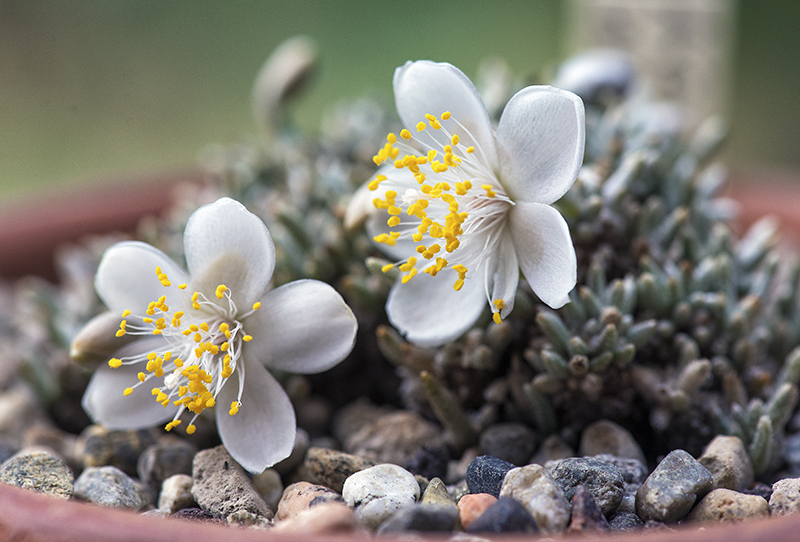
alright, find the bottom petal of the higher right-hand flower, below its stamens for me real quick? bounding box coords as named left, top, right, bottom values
left=386, top=266, right=486, bottom=347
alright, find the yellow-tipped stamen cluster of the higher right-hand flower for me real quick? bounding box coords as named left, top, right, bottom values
left=368, top=111, right=514, bottom=321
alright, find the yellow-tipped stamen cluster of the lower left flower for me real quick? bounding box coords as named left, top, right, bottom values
left=108, top=267, right=261, bottom=434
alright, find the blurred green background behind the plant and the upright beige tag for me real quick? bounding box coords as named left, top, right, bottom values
left=0, top=0, right=800, bottom=199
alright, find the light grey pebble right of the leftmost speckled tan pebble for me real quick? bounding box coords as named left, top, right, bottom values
left=75, top=465, right=150, bottom=510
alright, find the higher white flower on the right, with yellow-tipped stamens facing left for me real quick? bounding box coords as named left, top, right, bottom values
left=346, top=60, right=585, bottom=346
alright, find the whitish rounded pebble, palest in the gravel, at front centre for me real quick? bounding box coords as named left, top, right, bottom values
left=342, top=463, right=419, bottom=529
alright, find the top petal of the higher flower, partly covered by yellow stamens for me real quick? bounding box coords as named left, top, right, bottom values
left=394, top=60, right=497, bottom=170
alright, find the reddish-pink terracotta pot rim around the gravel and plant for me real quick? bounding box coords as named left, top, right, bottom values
left=0, top=172, right=800, bottom=542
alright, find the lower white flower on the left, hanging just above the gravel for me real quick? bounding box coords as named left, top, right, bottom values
left=83, top=198, right=357, bottom=472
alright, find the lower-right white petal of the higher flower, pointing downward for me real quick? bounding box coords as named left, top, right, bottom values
left=509, top=202, right=577, bottom=309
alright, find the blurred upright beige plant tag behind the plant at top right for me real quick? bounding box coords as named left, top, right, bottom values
left=567, top=0, right=734, bottom=123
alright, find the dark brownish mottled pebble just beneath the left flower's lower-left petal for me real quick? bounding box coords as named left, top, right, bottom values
left=76, top=425, right=156, bottom=476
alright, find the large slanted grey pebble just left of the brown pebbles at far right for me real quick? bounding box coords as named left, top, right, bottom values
left=636, top=450, right=713, bottom=523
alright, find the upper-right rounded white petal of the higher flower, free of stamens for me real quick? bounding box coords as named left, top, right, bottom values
left=497, top=86, right=586, bottom=203
